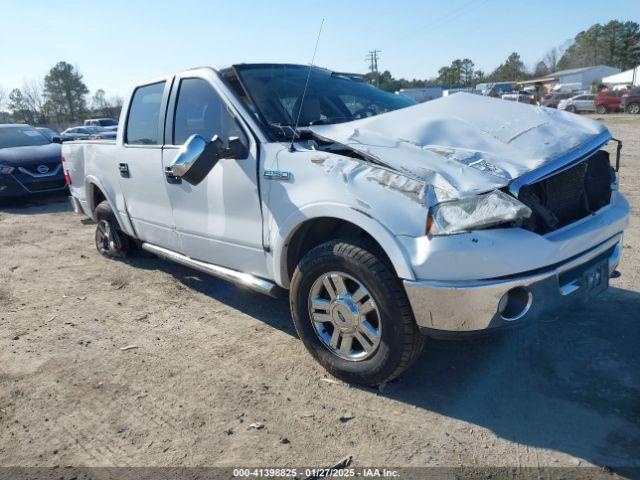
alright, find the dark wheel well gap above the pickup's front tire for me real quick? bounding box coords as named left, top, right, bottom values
left=284, top=217, right=395, bottom=284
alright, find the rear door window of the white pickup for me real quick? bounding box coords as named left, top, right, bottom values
left=125, top=82, right=164, bottom=145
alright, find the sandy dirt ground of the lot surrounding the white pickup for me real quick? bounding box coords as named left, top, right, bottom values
left=0, top=115, right=640, bottom=467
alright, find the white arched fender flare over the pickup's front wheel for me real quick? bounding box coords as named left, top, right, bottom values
left=270, top=204, right=415, bottom=288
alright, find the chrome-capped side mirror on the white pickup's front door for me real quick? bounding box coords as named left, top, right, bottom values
left=169, top=135, right=225, bottom=185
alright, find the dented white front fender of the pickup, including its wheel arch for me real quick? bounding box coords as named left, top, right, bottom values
left=263, top=145, right=428, bottom=287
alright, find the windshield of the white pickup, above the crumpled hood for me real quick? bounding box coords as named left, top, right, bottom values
left=234, top=64, right=416, bottom=135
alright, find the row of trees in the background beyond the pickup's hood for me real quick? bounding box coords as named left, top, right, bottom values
left=365, top=20, right=640, bottom=92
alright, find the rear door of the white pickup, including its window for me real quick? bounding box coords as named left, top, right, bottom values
left=114, top=79, right=179, bottom=250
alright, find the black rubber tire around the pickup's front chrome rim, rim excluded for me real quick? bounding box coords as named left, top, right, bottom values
left=290, top=240, right=425, bottom=385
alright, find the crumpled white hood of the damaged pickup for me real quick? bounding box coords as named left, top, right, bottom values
left=310, top=93, right=610, bottom=197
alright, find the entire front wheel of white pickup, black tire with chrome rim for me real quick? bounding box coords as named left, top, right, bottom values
left=290, top=240, right=425, bottom=385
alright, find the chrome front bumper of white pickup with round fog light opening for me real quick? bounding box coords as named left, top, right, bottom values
left=404, top=233, right=622, bottom=332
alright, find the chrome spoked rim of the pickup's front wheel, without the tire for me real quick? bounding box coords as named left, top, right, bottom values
left=309, top=272, right=382, bottom=361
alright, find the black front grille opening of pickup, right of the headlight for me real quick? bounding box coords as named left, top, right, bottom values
left=518, top=150, right=613, bottom=234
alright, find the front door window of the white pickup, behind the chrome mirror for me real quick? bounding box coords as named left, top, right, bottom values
left=173, top=78, right=248, bottom=152
